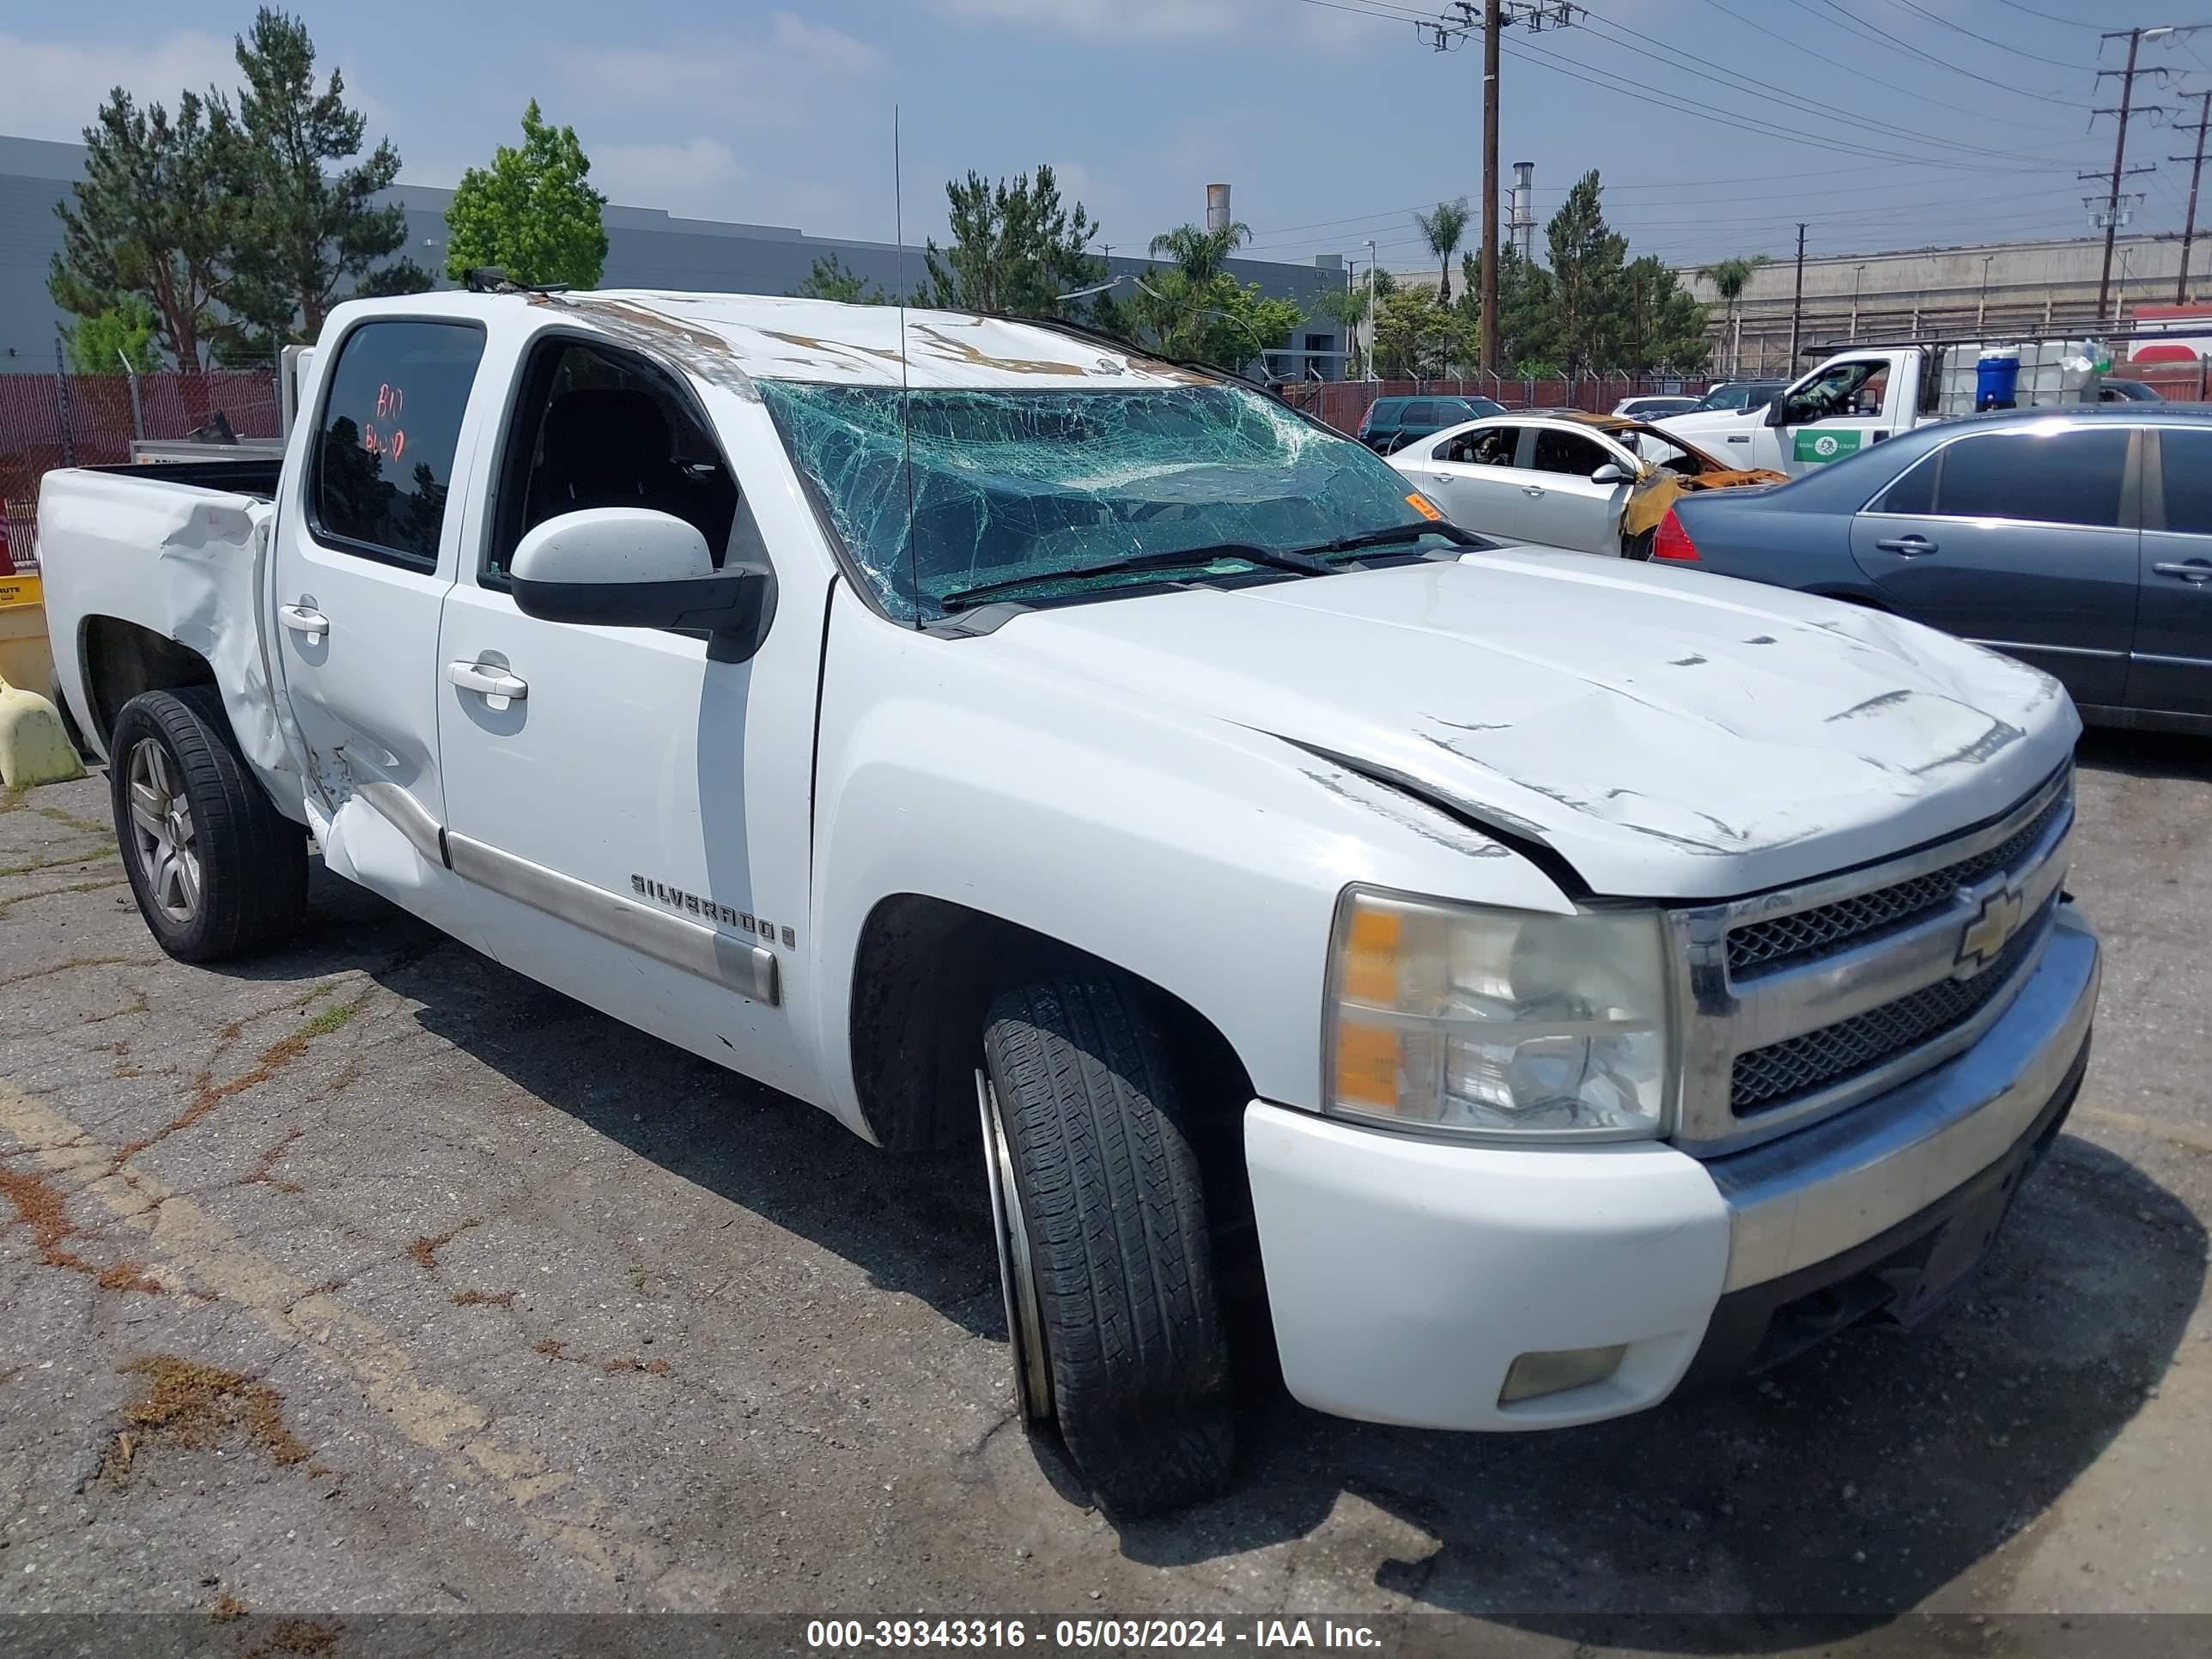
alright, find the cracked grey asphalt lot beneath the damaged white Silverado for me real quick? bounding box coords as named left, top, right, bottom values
left=0, top=734, right=2212, bottom=1652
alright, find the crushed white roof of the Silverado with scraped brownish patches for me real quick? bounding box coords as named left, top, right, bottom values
left=544, top=289, right=1207, bottom=392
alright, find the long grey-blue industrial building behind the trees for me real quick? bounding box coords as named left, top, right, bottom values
left=0, top=137, right=1345, bottom=380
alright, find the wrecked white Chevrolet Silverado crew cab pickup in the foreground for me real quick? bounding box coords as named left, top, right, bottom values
left=40, top=292, right=2100, bottom=1516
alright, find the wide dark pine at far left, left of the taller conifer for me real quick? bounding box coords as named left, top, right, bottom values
left=46, top=86, right=239, bottom=372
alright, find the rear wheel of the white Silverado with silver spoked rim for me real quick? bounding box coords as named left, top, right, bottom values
left=108, top=686, right=307, bottom=963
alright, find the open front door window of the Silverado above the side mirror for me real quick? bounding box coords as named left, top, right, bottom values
left=484, top=341, right=737, bottom=586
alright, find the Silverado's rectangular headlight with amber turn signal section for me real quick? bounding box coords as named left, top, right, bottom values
left=1325, top=887, right=1672, bottom=1139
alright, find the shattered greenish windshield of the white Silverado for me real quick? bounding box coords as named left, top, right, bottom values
left=759, top=380, right=1427, bottom=622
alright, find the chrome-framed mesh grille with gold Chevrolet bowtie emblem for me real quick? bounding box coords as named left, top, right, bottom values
left=1666, top=763, right=2073, bottom=1157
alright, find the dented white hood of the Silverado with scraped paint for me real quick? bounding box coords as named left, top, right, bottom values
left=991, top=549, right=2079, bottom=898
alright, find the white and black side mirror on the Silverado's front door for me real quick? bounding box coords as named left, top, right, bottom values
left=507, top=507, right=776, bottom=661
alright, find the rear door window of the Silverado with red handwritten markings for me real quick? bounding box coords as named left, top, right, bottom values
left=307, top=321, right=484, bottom=568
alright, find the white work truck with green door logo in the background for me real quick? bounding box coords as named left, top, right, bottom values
left=1652, top=338, right=2108, bottom=477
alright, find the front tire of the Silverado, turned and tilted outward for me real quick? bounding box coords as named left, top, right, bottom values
left=984, top=964, right=1234, bottom=1517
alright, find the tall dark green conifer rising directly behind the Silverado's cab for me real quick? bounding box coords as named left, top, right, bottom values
left=216, top=7, right=429, bottom=347
